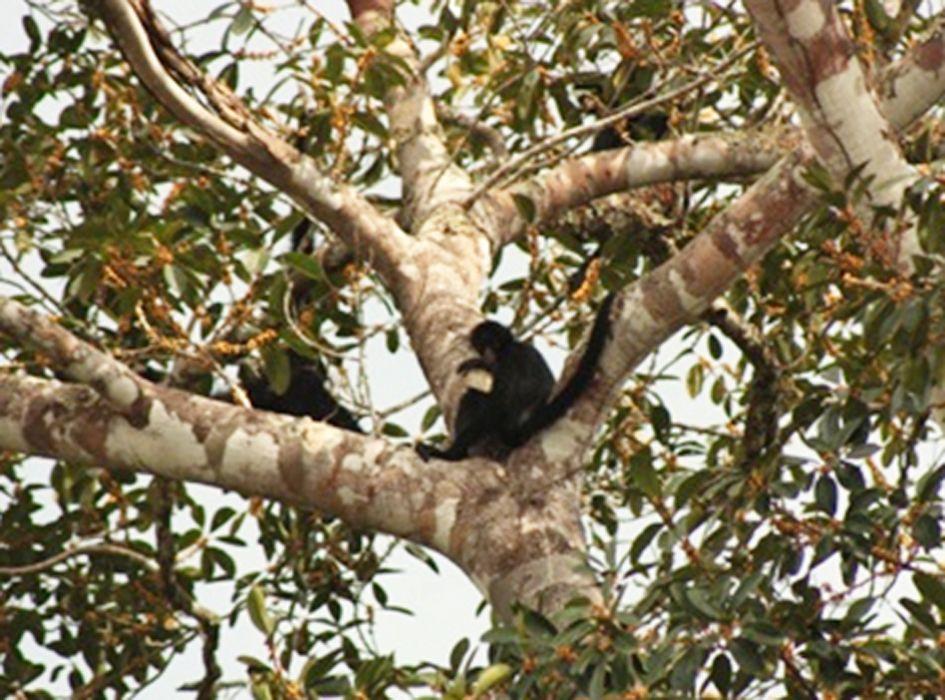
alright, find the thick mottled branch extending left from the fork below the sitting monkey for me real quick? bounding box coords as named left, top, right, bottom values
left=0, top=374, right=494, bottom=552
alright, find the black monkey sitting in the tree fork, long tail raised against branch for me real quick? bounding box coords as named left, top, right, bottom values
left=417, top=293, right=614, bottom=461
